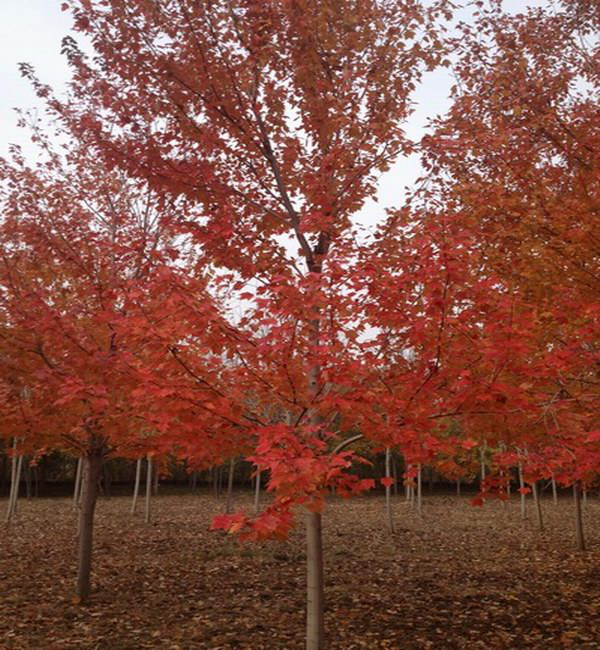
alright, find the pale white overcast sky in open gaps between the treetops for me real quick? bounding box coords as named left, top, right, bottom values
left=0, top=0, right=548, bottom=223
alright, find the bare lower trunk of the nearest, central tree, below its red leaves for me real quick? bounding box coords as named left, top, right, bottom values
left=306, top=512, right=325, bottom=650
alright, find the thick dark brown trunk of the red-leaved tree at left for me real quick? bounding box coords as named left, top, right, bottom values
left=77, top=451, right=102, bottom=605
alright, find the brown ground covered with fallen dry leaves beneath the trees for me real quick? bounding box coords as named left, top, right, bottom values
left=0, top=493, right=600, bottom=650
